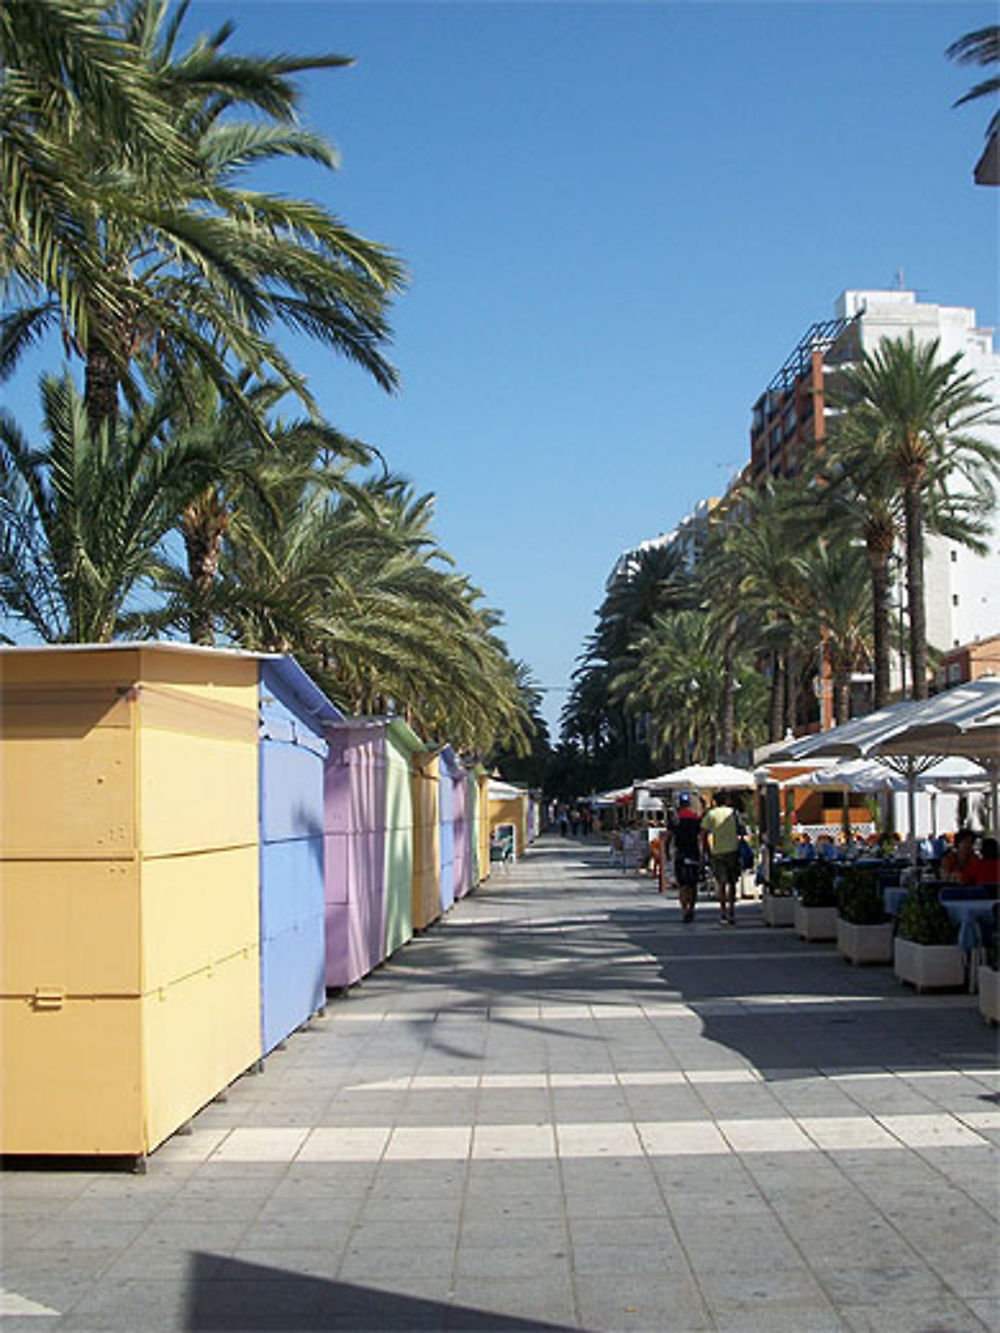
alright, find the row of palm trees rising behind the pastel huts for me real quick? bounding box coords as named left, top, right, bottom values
left=0, top=0, right=533, bottom=754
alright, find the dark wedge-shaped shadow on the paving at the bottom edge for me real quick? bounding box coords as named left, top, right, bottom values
left=184, top=1253, right=569, bottom=1333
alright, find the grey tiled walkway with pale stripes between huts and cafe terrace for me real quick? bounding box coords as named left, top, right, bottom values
left=0, top=838, right=1000, bottom=1333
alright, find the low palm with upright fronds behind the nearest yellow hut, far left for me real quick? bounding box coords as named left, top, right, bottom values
left=0, top=373, right=211, bottom=643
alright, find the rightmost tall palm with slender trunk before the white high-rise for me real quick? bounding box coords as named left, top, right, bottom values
left=831, top=333, right=1000, bottom=698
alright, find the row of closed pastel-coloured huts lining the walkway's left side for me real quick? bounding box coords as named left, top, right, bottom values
left=0, top=643, right=539, bottom=1161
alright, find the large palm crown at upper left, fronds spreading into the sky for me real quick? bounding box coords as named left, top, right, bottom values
left=0, top=0, right=403, bottom=424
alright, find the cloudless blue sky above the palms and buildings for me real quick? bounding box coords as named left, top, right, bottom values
left=3, top=0, right=1000, bottom=720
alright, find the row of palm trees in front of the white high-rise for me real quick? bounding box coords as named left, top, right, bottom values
left=563, top=336, right=1000, bottom=777
